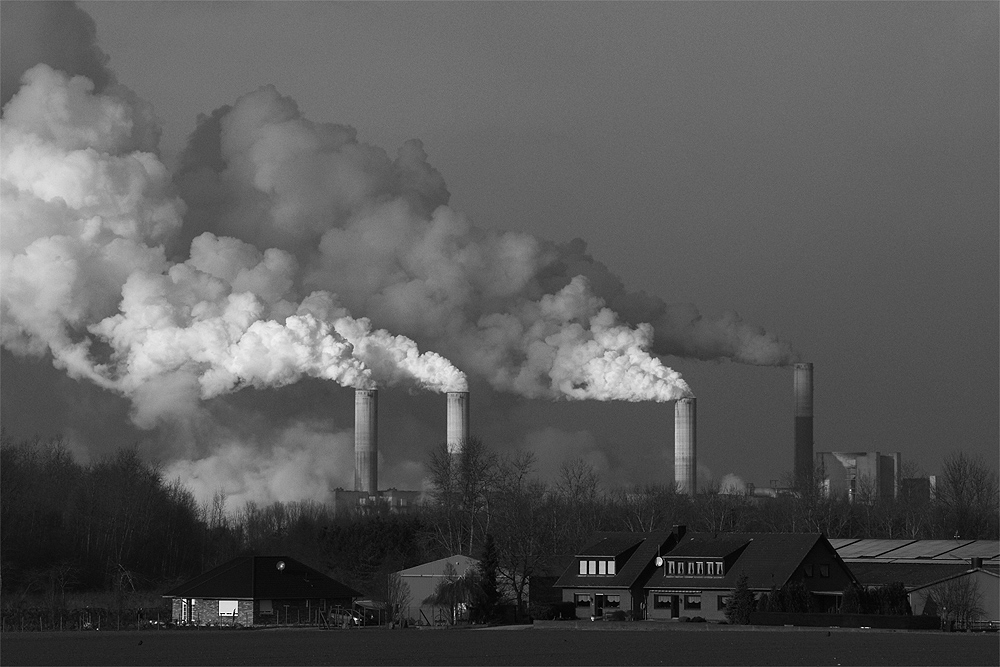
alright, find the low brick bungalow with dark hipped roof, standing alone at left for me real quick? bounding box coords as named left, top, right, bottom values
left=163, top=556, right=361, bottom=626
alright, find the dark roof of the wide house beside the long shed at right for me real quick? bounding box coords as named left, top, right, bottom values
left=644, top=533, right=836, bottom=590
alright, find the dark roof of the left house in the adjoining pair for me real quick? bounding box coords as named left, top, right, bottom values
left=554, top=530, right=674, bottom=588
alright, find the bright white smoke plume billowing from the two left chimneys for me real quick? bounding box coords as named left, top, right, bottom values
left=0, top=65, right=465, bottom=427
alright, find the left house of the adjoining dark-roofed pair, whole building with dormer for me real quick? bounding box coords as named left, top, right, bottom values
left=555, top=531, right=676, bottom=619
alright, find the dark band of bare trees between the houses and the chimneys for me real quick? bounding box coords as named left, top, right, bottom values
left=0, top=437, right=1000, bottom=608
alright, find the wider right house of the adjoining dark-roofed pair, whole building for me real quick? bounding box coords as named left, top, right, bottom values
left=643, top=527, right=857, bottom=620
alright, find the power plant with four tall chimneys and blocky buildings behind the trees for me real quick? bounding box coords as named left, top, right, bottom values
left=332, top=363, right=844, bottom=512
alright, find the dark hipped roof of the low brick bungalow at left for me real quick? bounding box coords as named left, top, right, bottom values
left=163, top=556, right=361, bottom=600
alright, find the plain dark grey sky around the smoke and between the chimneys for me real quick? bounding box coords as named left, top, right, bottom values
left=2, top=2, right=1000, bottom=508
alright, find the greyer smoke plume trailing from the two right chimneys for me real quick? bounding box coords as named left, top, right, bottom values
left=177, top=86, right=793, bottom=401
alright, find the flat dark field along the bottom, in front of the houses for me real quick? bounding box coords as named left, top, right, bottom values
left=0, top=628, right=1000, bottom=666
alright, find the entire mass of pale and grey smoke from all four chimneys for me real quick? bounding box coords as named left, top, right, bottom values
left=0, top=3, right=795, bottom=504
